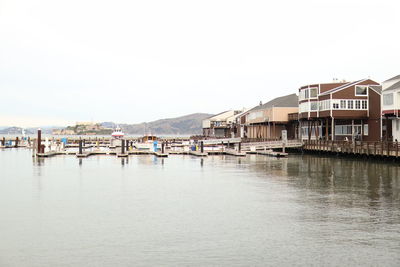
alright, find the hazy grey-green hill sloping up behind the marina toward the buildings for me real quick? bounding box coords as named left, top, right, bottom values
left=102, top=113, right=212, bottom=135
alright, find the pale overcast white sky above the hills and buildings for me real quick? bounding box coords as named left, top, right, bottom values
left=0, top=0, right=400, bottom=127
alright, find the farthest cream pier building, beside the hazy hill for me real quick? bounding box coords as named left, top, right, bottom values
left=202, top=110, right=243, bottom=138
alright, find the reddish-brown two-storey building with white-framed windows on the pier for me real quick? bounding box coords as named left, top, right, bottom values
left=299, top=79, right=382, bottom=141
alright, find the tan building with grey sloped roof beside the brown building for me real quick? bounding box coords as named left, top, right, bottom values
left=245, top=94, right=298, bottom=140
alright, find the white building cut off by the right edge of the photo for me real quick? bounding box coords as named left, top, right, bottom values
left=382, top=75, right=400, bottom=141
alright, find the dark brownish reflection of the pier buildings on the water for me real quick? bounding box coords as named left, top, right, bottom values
left=250, top=155, right=400, bottom=206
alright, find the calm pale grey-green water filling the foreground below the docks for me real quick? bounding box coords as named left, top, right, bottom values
left=0, top=149, right=400, bottom=267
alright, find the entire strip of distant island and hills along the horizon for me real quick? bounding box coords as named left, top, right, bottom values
left=0, top=113, right=213, bottom=135
